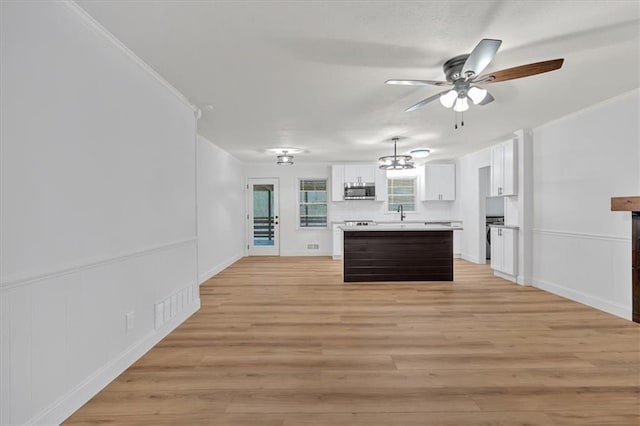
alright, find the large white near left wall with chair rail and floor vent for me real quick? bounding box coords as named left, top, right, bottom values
left=0, top=2, right=199, bottom=424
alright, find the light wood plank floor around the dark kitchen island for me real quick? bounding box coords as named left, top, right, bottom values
left=68, top=257, right=640, bottom=426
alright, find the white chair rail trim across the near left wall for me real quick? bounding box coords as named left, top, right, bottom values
left=0, top=237, right=198, bottom=291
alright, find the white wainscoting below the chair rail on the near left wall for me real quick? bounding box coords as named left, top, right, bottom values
left=0, top=239, right=199, bottom=424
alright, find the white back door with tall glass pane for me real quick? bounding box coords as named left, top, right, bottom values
left=247, top=178, right=280, bottom=256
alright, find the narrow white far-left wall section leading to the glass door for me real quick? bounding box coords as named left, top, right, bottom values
left=197, top=136, right=246, bottom=283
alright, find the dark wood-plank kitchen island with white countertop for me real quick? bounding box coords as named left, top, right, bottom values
left=342, top=224, right=462, bottom=282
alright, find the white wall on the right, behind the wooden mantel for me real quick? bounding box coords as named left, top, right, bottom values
left=533, top=90, right=640, bottom=318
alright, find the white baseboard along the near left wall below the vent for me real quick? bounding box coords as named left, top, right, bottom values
left=26, top=298, right=200, bottom=425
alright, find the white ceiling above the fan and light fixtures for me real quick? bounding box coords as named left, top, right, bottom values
left=78, top=0, right=640, bottom=164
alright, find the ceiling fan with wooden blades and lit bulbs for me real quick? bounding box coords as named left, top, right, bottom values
left=386, top=38, right=564, bottom=118
